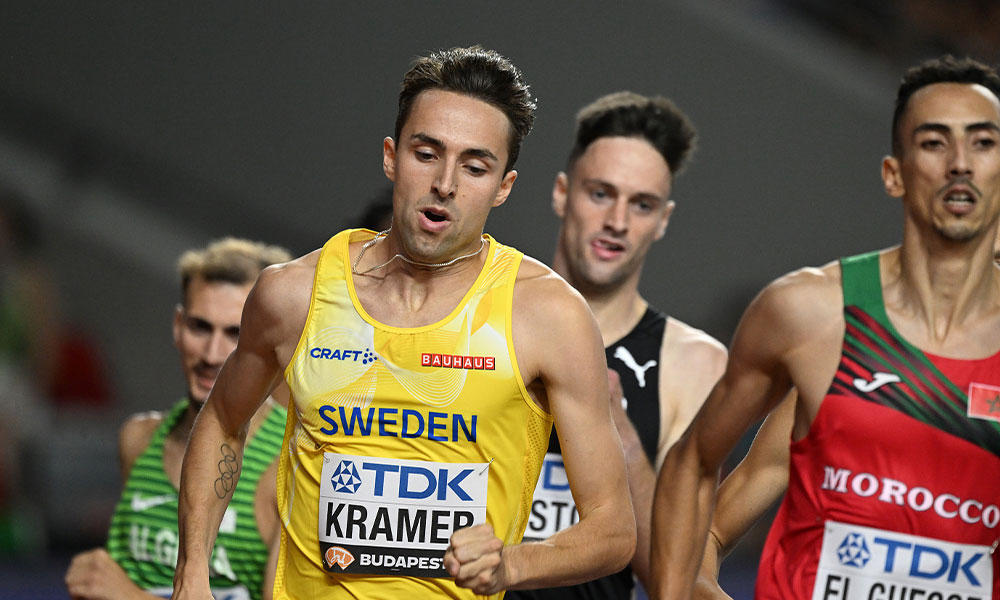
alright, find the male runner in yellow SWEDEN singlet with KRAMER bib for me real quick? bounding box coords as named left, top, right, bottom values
left=175, top=47, right=635, bottom=600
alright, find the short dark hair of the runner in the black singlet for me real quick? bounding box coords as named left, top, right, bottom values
left=568, top=92, right=697, bottom=174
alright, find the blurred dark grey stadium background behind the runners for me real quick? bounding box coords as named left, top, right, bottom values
left=0, top=0, right=1000, bottom=598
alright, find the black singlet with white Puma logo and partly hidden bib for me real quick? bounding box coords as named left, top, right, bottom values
left=507, top=307, right=667, bottom=600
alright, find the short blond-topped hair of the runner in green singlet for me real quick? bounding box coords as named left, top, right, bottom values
left=177, top=237, right=292, bottom=305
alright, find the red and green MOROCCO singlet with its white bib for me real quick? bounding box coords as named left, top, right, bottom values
left=756, top=253, right=1000, bottom=600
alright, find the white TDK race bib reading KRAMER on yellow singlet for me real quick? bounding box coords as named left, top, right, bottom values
left=319, top=452, right=489, bottom=577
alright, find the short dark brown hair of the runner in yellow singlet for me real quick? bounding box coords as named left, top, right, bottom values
left=396, top=46, right=536, bottom=172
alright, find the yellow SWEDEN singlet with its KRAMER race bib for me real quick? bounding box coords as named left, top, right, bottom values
left=275, top=230, right=552, bottom=599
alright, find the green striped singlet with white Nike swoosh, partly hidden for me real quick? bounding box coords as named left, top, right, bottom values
left=108, top=399, right=286, bottom=600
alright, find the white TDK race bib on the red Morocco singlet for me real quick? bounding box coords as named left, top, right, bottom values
left=812, top=521, right=993, bottom=600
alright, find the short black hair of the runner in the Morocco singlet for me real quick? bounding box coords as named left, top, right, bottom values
left=892, top=54, right=1000, bottom=155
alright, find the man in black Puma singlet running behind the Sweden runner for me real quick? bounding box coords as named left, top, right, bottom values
left=507, top=92, right=725, bottom=599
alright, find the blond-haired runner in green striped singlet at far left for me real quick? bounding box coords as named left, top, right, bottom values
left=66, top=238, right=290, bottom=600
